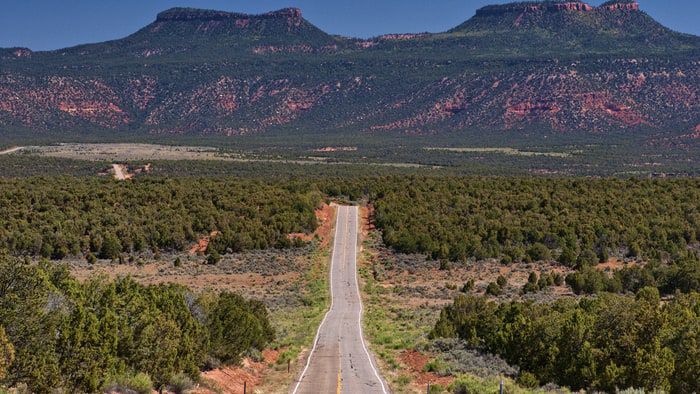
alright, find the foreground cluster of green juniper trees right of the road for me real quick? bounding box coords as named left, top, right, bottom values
left=431, top=287, right=700, bottom=394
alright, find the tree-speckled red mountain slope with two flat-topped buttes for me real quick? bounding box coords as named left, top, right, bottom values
left=0, top=1, right=700, bottom=135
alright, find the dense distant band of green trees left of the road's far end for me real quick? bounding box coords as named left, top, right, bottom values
left=0, top=177, right=321, bottom=259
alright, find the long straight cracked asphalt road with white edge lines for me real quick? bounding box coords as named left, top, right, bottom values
left=291, top=206, right=388, bottom=394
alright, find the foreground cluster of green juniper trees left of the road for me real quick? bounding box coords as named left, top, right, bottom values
left=0, top=256, right=274, bottom=392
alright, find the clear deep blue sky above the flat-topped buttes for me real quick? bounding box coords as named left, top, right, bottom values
left=0, top=0, right=700, bottom=50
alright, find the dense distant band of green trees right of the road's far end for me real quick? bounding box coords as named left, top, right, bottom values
left=360, top=177, right=700, bottom=267
